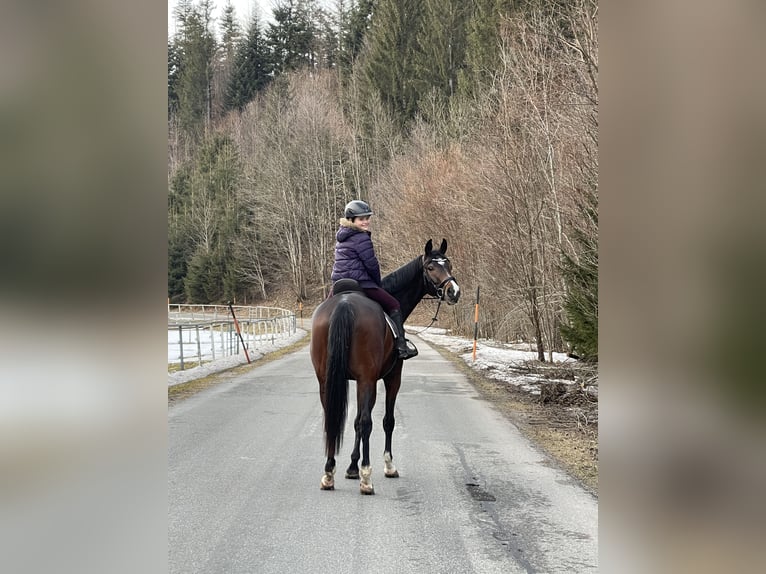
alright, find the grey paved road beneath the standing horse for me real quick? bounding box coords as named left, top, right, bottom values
left=168, top=341, right=598, bottom=574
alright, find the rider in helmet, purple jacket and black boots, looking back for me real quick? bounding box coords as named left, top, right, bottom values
left=332, top=199, right=418, bottom=360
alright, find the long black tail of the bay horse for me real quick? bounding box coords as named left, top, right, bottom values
left=324, top=300, right=354, bottom=456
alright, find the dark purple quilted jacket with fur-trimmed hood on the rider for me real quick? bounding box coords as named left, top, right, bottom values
left=332, top=218, right=382, bottom=288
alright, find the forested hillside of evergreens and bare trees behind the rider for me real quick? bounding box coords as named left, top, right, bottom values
left=167, top=0, right=599, bottom=361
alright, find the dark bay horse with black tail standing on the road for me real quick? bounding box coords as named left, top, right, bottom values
left=310, top=239, right=460, bottom=494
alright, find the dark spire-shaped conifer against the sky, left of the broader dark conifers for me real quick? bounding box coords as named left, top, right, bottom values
left=225, top=13, right=271, bottom=110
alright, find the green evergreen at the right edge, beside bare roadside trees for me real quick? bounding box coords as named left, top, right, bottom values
left=561, top=193, right=598, bottom=362
